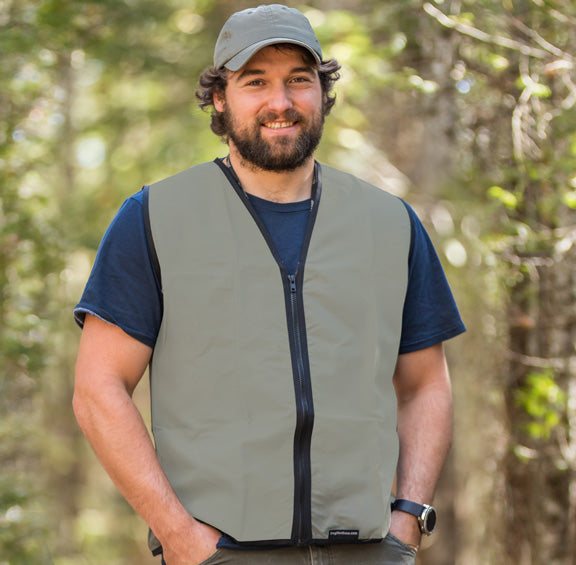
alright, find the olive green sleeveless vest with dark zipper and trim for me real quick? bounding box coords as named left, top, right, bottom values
left=148, top=162, right=411, bottom=545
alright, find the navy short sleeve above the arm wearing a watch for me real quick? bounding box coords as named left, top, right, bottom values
left=399, top=203, right=466, bottom=353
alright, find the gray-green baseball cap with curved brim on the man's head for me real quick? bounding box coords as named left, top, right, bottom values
left=214, top=4, right=322, bottom=71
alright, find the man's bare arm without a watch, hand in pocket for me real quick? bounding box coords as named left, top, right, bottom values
left=73, top=315, right=220, bottom=565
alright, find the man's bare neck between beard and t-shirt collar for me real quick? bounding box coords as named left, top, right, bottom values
left=230, top=144, right=314, bottom=203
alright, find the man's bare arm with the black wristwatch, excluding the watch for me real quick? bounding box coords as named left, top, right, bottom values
left=390, top=343, right=452, bottom=546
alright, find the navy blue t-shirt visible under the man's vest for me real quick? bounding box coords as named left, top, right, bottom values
left=74, top=185, right=465, bottom=353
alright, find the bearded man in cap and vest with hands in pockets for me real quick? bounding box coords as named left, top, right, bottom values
left=74, top=5, right=464, bottom=565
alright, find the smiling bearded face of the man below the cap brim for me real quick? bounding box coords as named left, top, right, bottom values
left=214, top=46, right=324, bottom=172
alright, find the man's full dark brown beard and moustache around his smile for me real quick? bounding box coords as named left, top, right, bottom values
left=223, top=106, right=324, bottom=172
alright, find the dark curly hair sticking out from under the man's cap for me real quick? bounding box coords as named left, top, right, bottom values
left=196, top=44, right=340, bottom=141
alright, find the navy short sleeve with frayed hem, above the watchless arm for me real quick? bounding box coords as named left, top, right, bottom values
left=74, top=193, right=162, bottom=347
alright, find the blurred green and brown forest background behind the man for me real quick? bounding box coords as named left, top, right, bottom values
left=0, top=0, right=576, bottom=565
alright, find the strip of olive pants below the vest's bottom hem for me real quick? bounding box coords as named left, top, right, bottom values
left=160, top=534, right=416, bottom=565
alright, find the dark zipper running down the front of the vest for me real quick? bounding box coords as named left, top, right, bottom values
left=288, top=275, right=314, bottom=545
